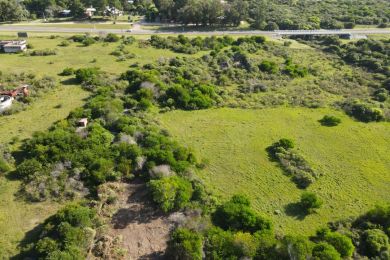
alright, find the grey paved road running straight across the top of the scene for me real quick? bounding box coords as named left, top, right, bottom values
left=0, top=25, right=390, bottom=36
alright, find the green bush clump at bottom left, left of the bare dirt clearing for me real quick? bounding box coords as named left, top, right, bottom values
left=21, top=204, right=96, bottom=259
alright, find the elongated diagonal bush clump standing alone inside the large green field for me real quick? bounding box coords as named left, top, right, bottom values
left=267, top=139, right=319, bottom=189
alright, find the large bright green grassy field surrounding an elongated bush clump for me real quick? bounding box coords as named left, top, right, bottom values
left=158, top=107, right=390, bottom=234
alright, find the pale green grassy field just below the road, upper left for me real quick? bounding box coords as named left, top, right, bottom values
left=0, top=35, right=202, bottom=76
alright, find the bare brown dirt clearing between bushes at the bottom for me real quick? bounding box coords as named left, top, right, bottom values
left=110, top=183, right=172, bottom=260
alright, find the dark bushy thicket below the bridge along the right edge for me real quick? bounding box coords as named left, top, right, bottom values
left=299, top=36, right=390, bottom=122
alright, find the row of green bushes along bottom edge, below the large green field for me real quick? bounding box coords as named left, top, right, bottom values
left=167, top=195, right=362, bottom=260
